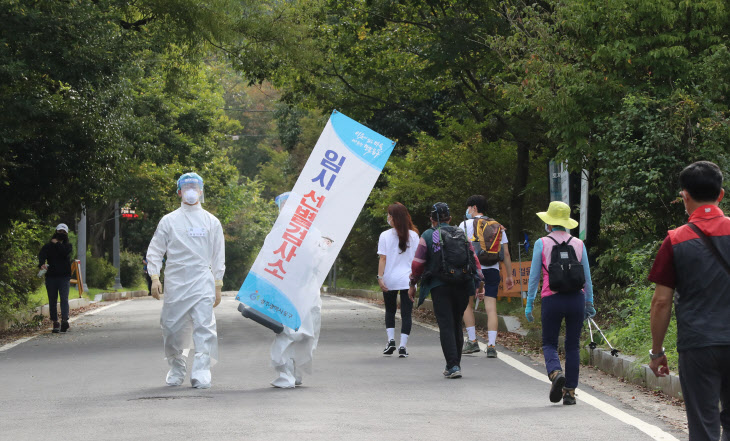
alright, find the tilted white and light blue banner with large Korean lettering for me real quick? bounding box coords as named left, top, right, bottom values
left=236, top=110, right=395, bottom=330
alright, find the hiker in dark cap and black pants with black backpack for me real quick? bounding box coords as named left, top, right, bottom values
left=408, top=202, right=484, bottom=378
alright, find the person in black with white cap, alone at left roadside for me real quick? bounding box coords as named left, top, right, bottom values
left=38, top=224, right=73, bottom=334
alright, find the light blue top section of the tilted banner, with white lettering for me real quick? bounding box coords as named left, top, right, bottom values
left=328, top=110, right=395, bottom=172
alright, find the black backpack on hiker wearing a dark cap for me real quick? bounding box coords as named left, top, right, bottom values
left=432, top=226, right=476, bottom=283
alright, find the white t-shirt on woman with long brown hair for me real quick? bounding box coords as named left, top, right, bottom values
left=378, top=228, right=419, bottom=291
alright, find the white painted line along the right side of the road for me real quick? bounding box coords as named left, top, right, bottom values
left=336, top=297, right=679, bottom=441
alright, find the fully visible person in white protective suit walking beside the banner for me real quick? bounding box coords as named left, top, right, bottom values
left=147, top=173, right=226, bottom=389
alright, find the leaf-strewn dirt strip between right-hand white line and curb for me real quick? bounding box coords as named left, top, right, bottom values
left=349, top=297, right=687, bottom=433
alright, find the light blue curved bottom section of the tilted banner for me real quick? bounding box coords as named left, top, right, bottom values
left=236, top=271, right=302, bottom=331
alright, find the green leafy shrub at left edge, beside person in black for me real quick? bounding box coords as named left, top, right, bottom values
left=0, top=222, right=47, bottom=318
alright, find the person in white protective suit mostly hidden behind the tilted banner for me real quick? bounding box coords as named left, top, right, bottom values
left=271, top=193, right=322, bottom=388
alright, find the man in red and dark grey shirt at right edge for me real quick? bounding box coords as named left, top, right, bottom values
left=649, top=161, right=730, bottom=441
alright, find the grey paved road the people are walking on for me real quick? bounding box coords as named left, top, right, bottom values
left=0, top=296, right=686, bottom=441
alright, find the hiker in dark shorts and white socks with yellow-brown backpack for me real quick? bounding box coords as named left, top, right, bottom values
left=459, top=194, right=514, bottom=358
